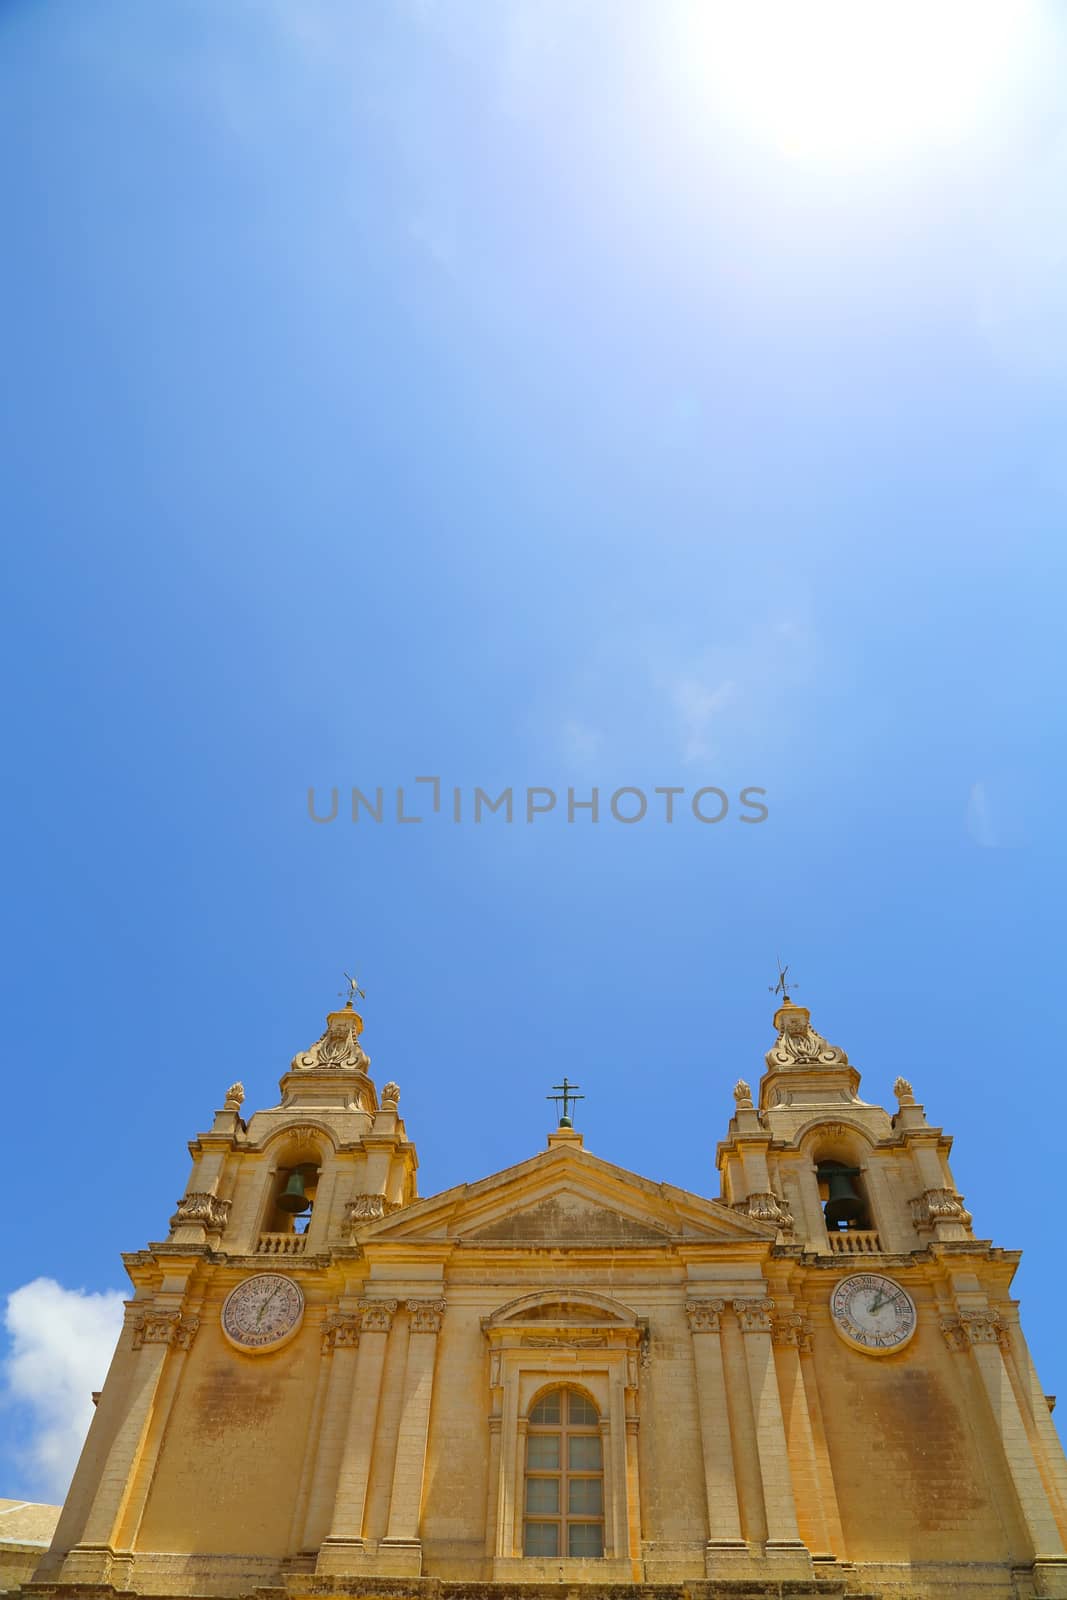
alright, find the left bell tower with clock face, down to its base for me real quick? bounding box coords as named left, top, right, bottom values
left=37, top=986, right=418, bottom=1592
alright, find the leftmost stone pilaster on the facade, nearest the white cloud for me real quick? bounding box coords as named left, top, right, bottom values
left=56, top=1307, right=200, bottom=1584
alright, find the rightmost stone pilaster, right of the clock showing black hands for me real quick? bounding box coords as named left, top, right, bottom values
left=941, top=1307, right=1067, bottom=1574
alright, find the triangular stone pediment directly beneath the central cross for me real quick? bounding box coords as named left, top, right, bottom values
left=358, top=1147, right=776, bottom=1250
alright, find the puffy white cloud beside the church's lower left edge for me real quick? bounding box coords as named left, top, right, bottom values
left=0, top=1278, right=123, bottom=1502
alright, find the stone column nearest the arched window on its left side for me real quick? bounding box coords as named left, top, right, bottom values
left=379, top=1299, right=445, bottom=1576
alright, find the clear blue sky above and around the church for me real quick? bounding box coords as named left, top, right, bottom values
left=0, top=0, right=1067, bottom=1498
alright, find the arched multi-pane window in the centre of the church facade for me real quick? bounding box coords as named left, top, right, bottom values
left=523, top=1389, right=603, bottom=1557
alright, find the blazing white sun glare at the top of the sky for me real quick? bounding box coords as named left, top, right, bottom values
left=675, top=0, right=1037, bottom=163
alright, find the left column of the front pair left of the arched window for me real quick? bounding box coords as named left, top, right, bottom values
left=319, top=1301, right=397, bottom=1573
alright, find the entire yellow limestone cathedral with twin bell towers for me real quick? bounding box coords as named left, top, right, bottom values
left=12, top=986, right=1067, bottom=1600
